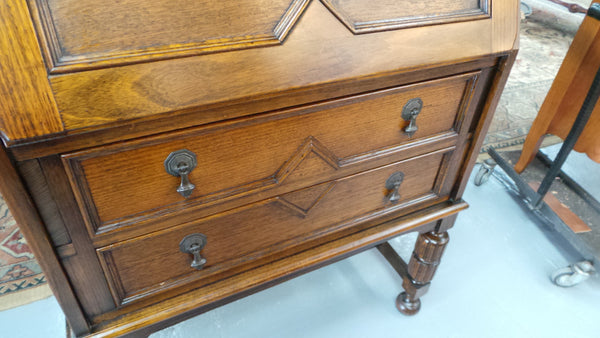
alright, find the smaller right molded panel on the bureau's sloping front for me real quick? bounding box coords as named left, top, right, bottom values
left=321, top=0, right=491, bottom=34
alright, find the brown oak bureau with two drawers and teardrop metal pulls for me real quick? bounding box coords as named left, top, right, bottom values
left=0, top=0, right=519, bottom=337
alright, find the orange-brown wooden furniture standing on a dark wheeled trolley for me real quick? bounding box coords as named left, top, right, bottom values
left=475, top=1, right=600, bottom=287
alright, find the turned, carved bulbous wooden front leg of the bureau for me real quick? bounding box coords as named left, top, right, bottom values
left=396, top=231, right=448, bottom=315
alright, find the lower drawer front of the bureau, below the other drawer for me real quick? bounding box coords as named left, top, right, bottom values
left=97, top=149, right=452, bottom=304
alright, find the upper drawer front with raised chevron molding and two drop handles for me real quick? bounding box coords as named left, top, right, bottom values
left=63, top=73, right=479, bottom=234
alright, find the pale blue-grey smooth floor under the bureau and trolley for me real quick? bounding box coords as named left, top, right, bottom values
left=0, top=149, right=600, bottom=338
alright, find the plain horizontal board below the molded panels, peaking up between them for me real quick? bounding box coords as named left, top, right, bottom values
left=52, top=0, right=518, bottom=130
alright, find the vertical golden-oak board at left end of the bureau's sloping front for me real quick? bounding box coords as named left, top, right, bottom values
left=0, top=0, right=63, bottom=142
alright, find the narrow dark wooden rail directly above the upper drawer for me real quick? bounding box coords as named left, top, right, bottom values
left=10, top=55, right=498, bottom=161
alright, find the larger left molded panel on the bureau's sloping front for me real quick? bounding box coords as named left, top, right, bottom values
left=28, top=0, right=310, bottom=74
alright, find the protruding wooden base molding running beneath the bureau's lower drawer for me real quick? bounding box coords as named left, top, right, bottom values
left=92, top=202, right=468, bottom=337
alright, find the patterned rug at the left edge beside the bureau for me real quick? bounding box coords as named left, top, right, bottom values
left=0, top=196, right=50, bottom=310
